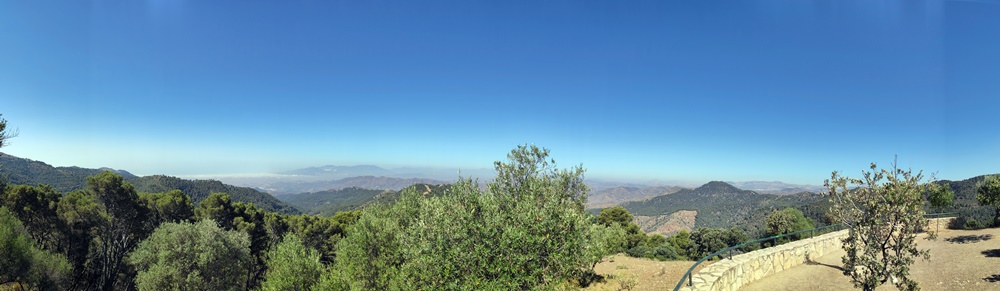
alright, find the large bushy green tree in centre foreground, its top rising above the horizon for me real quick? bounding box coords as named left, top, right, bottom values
left=335, top=146, right=611, bottom=289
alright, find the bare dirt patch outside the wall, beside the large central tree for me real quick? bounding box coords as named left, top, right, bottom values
left=584, top=254, right=710, bottom=290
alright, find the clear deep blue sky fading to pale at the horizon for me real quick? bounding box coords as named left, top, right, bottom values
left=0, top=0, right=1000, bottom=184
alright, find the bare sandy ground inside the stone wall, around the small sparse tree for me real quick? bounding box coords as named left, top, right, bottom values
left=741, top=228, right=1000, bottom=290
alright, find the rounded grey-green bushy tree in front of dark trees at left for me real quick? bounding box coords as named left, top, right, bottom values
left=128, top=219, right=252, bottom=290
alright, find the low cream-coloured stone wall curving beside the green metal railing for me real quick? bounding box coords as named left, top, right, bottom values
left=681, top=230, right=847, bottom=290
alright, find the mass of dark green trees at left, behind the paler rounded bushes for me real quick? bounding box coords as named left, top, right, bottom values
left=0, top=171, right=359, bottom=290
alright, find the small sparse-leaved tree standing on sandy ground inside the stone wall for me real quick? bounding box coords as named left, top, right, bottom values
left=825, top=163, right=930, bottom=290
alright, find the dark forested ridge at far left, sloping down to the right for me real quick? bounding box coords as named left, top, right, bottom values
left=0, top=154, right=299, bottom=214
